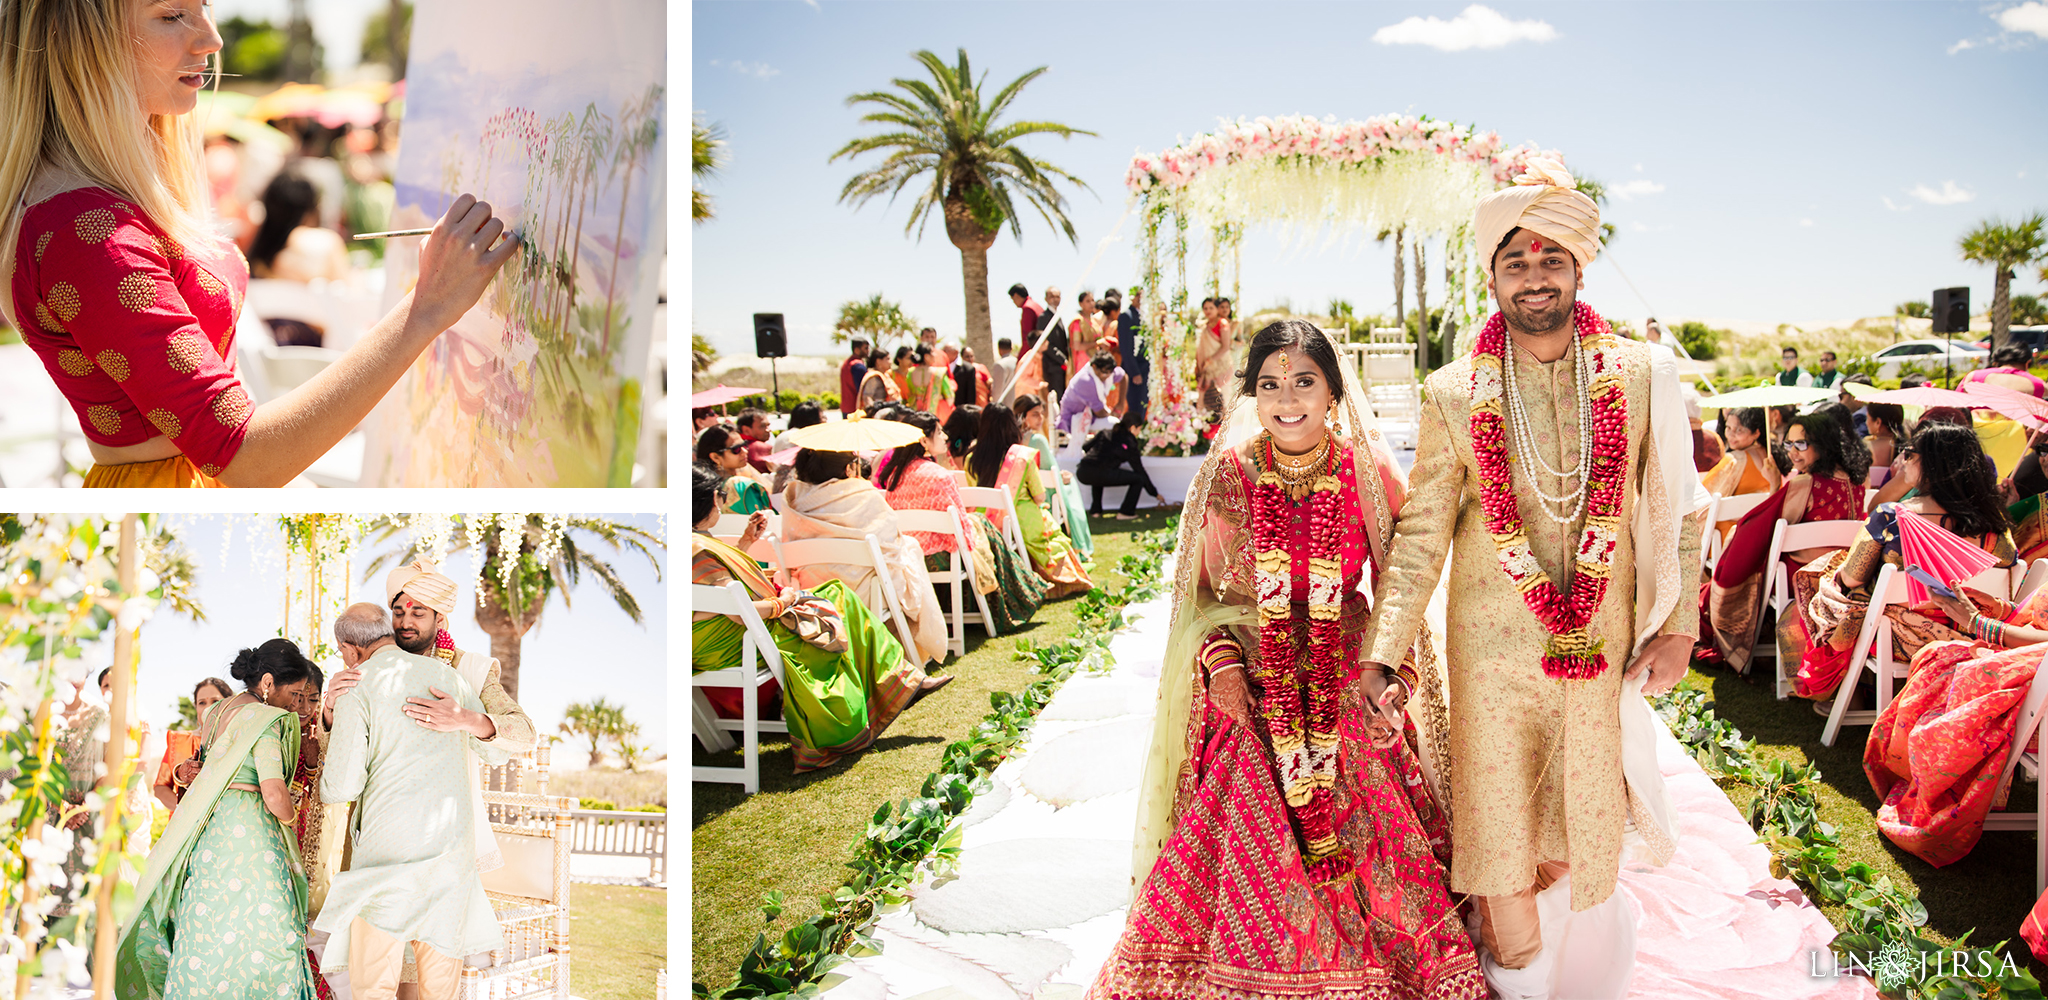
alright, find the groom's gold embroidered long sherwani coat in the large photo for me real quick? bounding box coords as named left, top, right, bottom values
left=1364, top=338, right=1700, bottom=910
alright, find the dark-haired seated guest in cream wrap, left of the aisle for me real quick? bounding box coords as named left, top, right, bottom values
left=782, top=449, right=946, bottom=664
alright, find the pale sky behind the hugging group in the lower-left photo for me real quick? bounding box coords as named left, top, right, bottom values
left=96, top=514, right=668, bottom=760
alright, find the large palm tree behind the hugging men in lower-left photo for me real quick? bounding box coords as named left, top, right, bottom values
left=362, top=514, right=668, bottom=701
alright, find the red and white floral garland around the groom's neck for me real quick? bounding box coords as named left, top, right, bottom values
left=1470, top=301, right=1628, bottom=680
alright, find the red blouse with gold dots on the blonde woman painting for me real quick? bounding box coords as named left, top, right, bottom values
left=12, top=189, right=256, bottom=475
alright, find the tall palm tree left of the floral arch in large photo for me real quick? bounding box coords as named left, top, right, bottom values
left=831, top=49, right=1094, bottom=359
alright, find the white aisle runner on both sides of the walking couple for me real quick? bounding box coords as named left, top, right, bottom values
left=825, top=568, right=1876, bottom=1000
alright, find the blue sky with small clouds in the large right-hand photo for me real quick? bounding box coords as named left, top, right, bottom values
left=688, top=0, right=2048, bottom=355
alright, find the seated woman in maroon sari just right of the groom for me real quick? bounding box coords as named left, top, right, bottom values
left=1694, top=414, right=1870, bottom=674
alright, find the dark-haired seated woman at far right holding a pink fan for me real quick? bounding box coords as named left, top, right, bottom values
left=1780, top=420, right=2013, bottom=701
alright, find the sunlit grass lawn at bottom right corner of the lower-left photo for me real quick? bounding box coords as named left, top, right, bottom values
left=569, top=885, right=668, bottom=1000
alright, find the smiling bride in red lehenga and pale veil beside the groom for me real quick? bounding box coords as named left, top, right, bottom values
left=1090, top=320, right=1487, bottom=1000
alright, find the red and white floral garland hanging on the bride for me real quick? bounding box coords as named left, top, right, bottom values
left=1251, top=436, right=1350, bottom=881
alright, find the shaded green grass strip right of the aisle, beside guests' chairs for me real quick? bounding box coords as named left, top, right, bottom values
left=1681, top=660, right=2048, bottom=977
